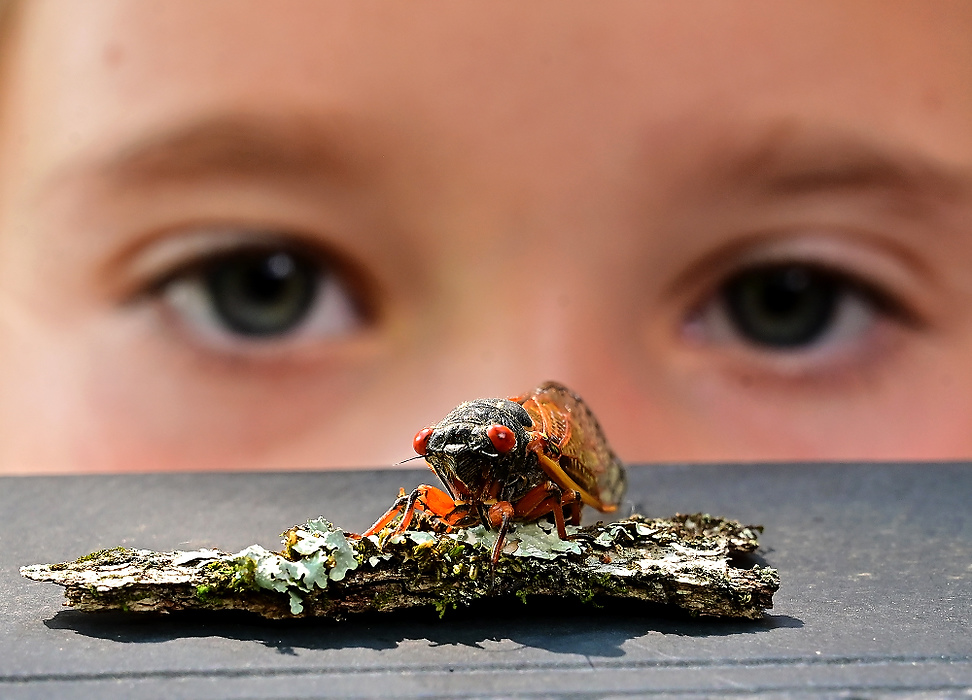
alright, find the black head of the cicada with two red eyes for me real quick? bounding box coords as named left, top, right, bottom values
left=415, top=399, right=533, bottom=501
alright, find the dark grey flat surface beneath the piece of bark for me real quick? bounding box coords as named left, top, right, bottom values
left=0, top=464, right=972, bottom=698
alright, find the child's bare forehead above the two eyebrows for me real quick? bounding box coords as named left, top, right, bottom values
left=9, top=0, right=972, bottom=179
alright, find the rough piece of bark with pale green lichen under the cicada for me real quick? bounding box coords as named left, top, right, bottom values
left=21, top=514, right=779, bottom=619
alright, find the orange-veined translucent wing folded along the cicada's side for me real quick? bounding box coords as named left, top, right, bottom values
left=513, top=382, right=627, bottom=511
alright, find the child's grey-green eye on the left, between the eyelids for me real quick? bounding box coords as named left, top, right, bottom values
left=161, top=245, right=363, bottom=343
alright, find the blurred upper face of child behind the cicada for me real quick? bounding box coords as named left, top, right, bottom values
left=0, top=0, right=972, bottom=471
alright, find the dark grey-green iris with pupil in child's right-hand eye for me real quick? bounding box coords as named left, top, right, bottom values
left=724, top=265, right=842, bottom=348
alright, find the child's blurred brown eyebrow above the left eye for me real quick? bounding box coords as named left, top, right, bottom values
left=79, top=115, right=366, bottom=191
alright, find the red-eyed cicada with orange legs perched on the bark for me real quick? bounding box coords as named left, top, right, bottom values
left=363, top=382, right=626, bottom=567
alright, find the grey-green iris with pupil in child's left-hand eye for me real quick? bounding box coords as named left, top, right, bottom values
left=204, top=251, right=320, bottom=337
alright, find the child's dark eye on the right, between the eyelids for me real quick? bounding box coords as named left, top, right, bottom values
left=691, top=262, right=905, bottom=353
